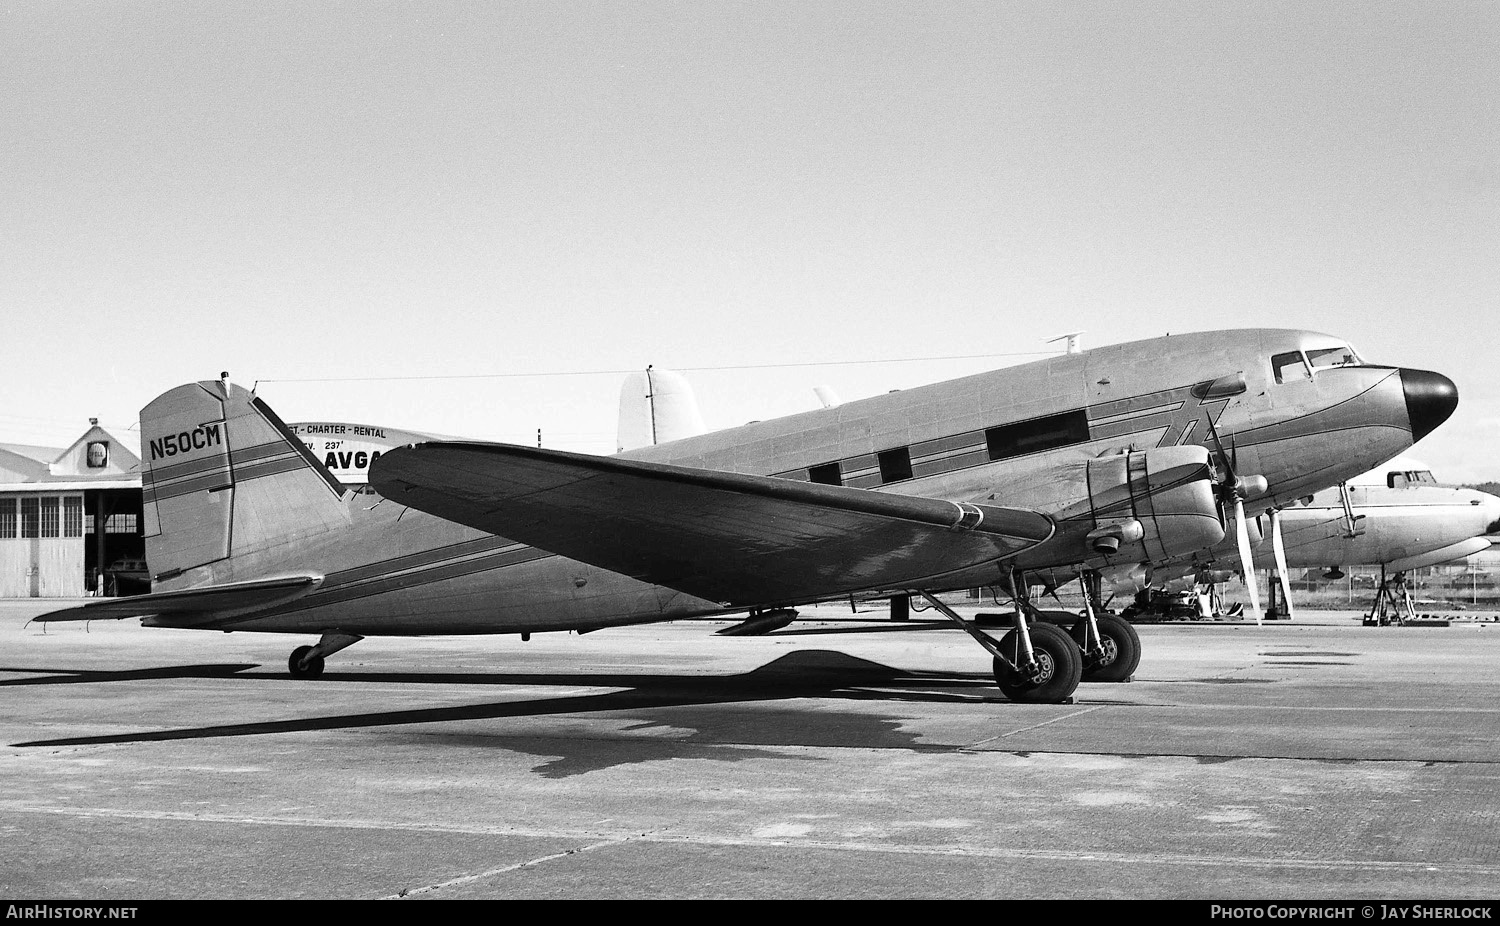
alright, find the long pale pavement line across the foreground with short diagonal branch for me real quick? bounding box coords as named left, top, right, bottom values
left=0, top=801, right=1500, bottom=876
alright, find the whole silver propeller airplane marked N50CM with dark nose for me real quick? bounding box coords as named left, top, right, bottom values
left=38, top=329, right=1458, bottom=704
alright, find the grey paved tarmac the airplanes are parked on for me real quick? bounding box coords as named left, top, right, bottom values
left=0, top=600, right=1500, bottom=900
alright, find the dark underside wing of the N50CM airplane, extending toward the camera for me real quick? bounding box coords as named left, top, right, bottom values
left=371, top=441, right=1055, bottom=606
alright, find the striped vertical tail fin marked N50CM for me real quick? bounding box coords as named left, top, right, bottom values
left=141, top=380, right=348, bottom=579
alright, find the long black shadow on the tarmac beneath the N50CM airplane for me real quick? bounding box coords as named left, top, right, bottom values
left=14, top=650, right=1008, bottom=746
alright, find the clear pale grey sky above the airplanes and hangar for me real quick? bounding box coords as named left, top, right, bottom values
left=0, top=0, right=1500, bottom=483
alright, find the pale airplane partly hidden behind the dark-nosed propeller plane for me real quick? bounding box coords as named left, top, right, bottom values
left=1134, top=456, right=1500, bottom=624
